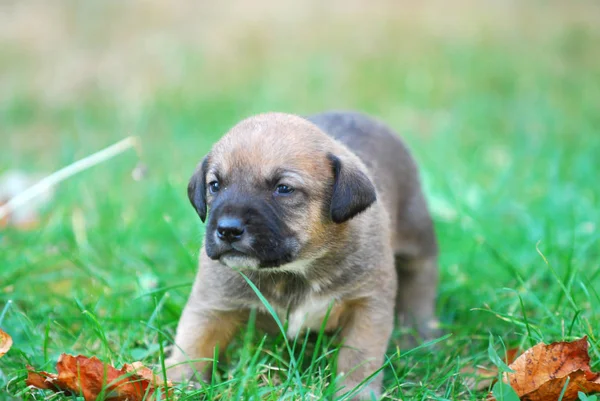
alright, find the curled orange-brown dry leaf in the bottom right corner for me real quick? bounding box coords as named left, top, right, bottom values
left=488, top=337, right=600, bottom=401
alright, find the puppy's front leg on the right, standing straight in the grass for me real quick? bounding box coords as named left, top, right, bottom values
left=338, top=299, right=394, bottom=400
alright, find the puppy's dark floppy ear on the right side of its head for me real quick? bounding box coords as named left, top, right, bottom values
left=327, top=153, right=377, bottom=223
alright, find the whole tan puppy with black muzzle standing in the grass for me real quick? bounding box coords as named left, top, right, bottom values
left=167, top=113, right=437, bottom=399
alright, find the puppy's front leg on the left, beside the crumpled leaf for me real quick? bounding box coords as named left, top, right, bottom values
left=165, top=304, right=243, bottom=382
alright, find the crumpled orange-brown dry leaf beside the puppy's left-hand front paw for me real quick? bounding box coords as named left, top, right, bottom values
left=27, top=354, right=171, bottom=401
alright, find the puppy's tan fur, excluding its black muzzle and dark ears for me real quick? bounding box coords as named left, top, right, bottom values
left=167, top=113, right=437, bottom=399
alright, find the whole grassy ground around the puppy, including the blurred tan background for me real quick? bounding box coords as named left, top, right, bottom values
left=0, top=1, right=600, bottom=400
